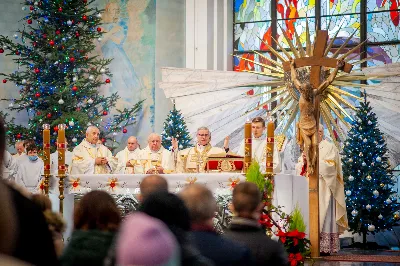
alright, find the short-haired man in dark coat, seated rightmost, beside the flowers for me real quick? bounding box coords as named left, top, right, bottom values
left=225, top=182, right=288, bottom=266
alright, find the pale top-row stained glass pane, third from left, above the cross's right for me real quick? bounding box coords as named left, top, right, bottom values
left=317, top=0, right=361, bottom=16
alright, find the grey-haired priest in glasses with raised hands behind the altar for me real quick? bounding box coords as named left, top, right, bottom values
left=177, top=127, right=229, bottom=173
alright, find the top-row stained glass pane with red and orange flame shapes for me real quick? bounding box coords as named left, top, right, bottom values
left=276, top=0, right=315, bottom=19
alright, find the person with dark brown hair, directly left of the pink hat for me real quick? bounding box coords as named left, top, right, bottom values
left=60, top=190, right=121, bottom=266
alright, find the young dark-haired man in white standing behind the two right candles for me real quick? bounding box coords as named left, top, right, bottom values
left=238, top=116, right=282, bottom=173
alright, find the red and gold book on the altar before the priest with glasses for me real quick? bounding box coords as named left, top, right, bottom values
left=205, top=152, right=244, bottom=172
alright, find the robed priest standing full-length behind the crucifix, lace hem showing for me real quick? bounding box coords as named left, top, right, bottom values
left=296, top=125, right=348, bottom=254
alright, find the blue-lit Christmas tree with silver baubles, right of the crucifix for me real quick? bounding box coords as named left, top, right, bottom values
left=342, top=95, right=399, bottom=244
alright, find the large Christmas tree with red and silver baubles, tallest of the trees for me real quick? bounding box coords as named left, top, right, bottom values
left=0, top=0, right=142, bottom=150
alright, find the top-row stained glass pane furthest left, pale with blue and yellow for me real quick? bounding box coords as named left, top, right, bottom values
left=234, top=0, right=271, bottom=23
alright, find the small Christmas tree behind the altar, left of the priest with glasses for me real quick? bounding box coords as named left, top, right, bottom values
left=161, top=104, right=192, bottom=150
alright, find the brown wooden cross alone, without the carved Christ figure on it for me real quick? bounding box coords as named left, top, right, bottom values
left=283, top=30, right=353, bottom=258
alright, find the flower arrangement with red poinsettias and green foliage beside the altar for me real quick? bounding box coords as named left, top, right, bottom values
left=246, top=161, right=311, bottom=266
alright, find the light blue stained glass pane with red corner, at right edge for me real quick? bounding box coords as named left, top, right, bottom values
left=367, top=11, right=400, bottom=42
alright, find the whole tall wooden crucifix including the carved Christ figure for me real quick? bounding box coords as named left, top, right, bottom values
left=283, top=30, right=353, bottom=258
